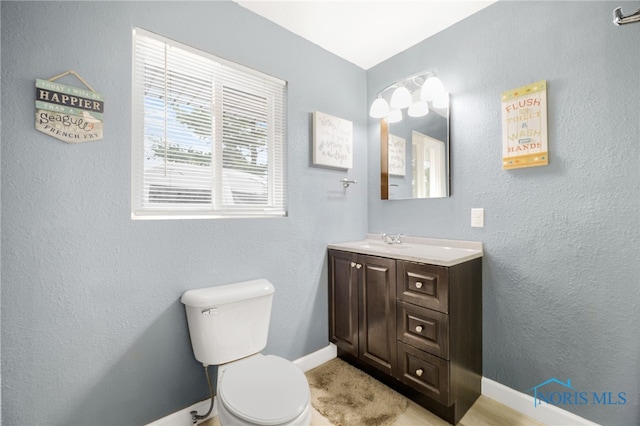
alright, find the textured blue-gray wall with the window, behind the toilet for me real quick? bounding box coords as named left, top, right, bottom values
left=1, top=1, right=367, bottom=425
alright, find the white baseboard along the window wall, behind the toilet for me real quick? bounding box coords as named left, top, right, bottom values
left=146, top=343, right=337, bottom=426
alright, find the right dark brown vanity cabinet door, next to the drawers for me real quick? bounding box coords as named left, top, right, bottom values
left=357, top=256, right=397, bottom=375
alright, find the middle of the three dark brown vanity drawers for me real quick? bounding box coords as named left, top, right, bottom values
left=396, top=302, right=449, bottom=359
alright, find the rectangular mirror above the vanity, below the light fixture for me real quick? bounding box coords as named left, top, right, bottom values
left=380, top=94, right=450, bottom=200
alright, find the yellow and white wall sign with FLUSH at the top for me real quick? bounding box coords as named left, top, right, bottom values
left=502, top=80, right=549, bottom=170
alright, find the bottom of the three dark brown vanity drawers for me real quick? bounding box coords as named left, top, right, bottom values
left=398, top=342, right=450, bottom=406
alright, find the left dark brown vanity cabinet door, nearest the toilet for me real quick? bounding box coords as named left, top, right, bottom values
left=329, top=250, right=358, bottom=356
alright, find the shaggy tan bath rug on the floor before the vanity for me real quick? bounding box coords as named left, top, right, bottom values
left=306, top=358, right=409, bottom=426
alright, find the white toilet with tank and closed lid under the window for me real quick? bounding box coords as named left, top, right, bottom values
left=181, top=279, right=311, bottom=426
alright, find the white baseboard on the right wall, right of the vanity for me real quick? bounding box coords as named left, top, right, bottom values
left=482, top=377, right=598, bottom=426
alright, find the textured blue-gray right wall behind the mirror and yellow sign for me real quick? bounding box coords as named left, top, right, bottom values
left=367, top=1, right=640, bottom=425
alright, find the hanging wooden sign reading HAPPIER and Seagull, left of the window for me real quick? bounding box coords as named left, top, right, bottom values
left=36, top=71, right=104, bottom=143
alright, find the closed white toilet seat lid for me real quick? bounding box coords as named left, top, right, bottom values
left=218, top=355, right=310, bottom=426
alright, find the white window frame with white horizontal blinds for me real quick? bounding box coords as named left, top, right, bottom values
left=131, top=27, right=287, bottom=219
